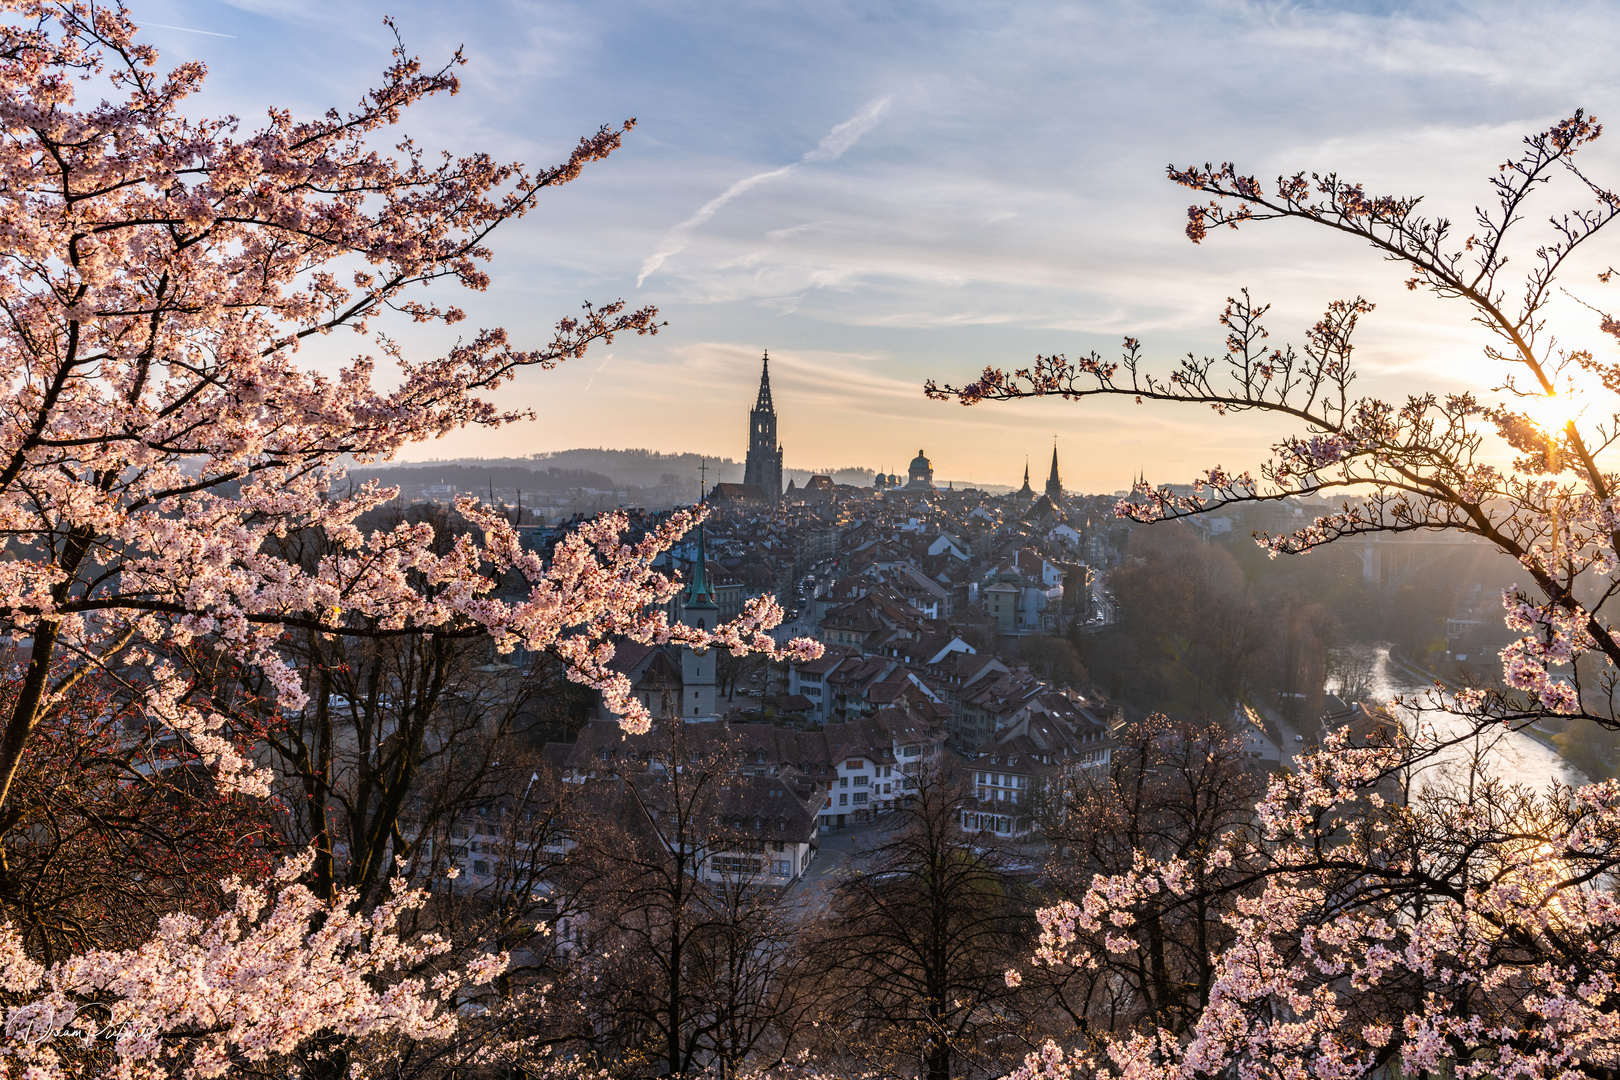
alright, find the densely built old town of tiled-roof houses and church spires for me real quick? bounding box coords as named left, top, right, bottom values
left=440, top=354, right=1278, bottom=887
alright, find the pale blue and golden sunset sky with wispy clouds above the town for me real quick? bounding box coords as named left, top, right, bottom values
left=131, top=0, right=1620, bottom=491
